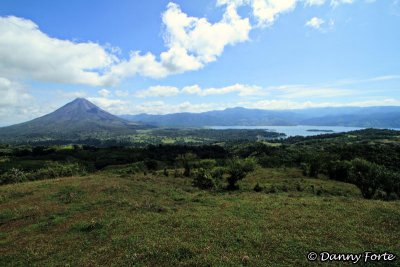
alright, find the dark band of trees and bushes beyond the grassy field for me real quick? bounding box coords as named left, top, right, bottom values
left=0, top=130, right=400, bottom=200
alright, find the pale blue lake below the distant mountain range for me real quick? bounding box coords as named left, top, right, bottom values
left=209, top=125, right=365, bottom=137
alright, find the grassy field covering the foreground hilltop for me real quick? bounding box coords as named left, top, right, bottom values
left=0, top=169, right=400, bottom=266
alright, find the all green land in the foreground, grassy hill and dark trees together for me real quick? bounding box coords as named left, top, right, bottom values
left=0, top=130, right=400, bottom=266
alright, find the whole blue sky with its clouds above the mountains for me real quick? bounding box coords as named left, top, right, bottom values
left=0, top=0, right=400, bottom=125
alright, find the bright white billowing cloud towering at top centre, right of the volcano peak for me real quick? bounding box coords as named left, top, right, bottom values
left=110, top=3, right=251, bottom=79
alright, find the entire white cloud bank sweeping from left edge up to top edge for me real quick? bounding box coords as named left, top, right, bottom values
left=0, top=0, right=360, bottom=86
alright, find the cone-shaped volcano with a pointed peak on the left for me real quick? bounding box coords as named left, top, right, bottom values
left=0, top=98, right=142, bottom=140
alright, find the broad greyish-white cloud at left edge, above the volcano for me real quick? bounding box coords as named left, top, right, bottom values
left=0, top=16, right=116, bottom=86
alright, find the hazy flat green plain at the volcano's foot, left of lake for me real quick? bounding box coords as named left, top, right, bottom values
left=0, top=126, right=284, bottom=147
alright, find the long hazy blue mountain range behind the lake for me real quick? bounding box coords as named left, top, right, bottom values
left=121, top=107, right=400, bottom=128
